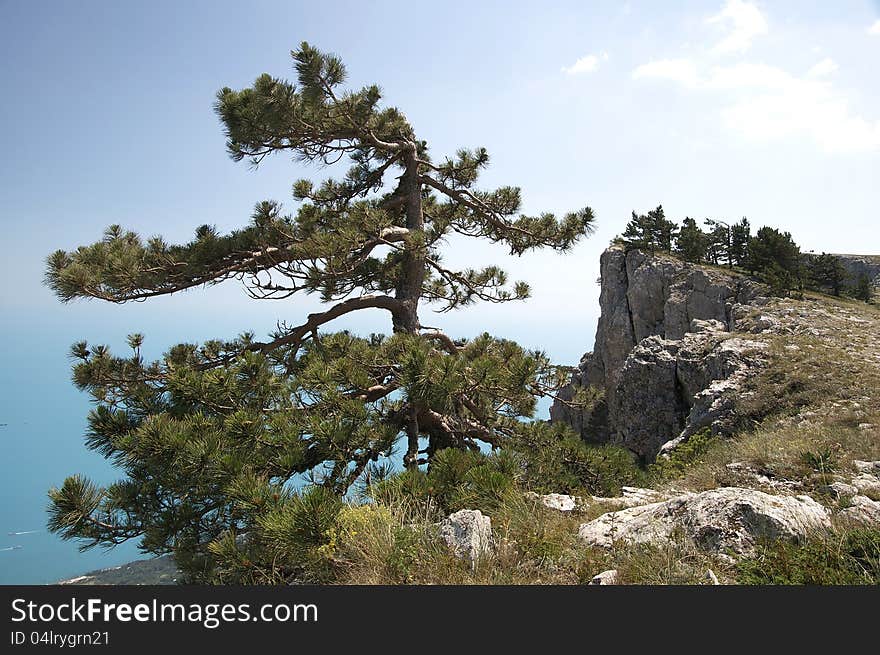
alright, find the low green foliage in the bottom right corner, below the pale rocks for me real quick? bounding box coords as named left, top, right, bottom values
left=736, top=528, right=880, bottom=585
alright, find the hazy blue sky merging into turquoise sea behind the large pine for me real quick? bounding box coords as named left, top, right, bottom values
left=0, top=0, right=880, bottom=581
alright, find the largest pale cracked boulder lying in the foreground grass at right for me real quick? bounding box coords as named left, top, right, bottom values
left=578, top=487, right=831, bottom=555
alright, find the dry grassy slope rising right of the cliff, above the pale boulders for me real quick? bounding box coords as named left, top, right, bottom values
left=667, top=324, right=880, bottom=498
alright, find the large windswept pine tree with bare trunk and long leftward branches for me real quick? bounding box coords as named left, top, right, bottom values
left=39, top=43, right=594, bottom=582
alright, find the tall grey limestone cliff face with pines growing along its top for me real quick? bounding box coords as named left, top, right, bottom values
left=550, top=246, right=764, bottom=460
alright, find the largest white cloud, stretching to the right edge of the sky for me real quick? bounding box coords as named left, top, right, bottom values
left=633, top=59, right=880, bottom=152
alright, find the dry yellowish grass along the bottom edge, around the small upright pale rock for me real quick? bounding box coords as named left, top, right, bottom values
left=324, top=495, right=733, bottom=585
